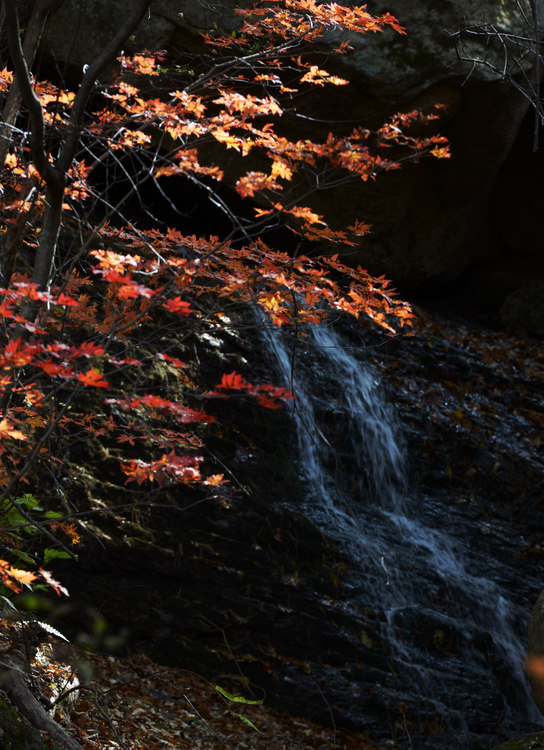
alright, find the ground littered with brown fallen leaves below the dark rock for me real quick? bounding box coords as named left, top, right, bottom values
left=29, top=645, right=386, bottom=750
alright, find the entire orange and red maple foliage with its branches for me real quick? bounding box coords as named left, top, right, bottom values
left=0, top=0, right=448, bottom=612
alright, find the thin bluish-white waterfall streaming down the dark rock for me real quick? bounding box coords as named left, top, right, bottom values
left=266, top=325, right=541, bottom=748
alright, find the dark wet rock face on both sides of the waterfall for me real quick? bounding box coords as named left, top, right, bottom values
left=49, top=306, right=544, bottom=750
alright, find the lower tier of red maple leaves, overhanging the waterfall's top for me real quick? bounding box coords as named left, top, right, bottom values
left=0, top=229, right=411, bottom=486
